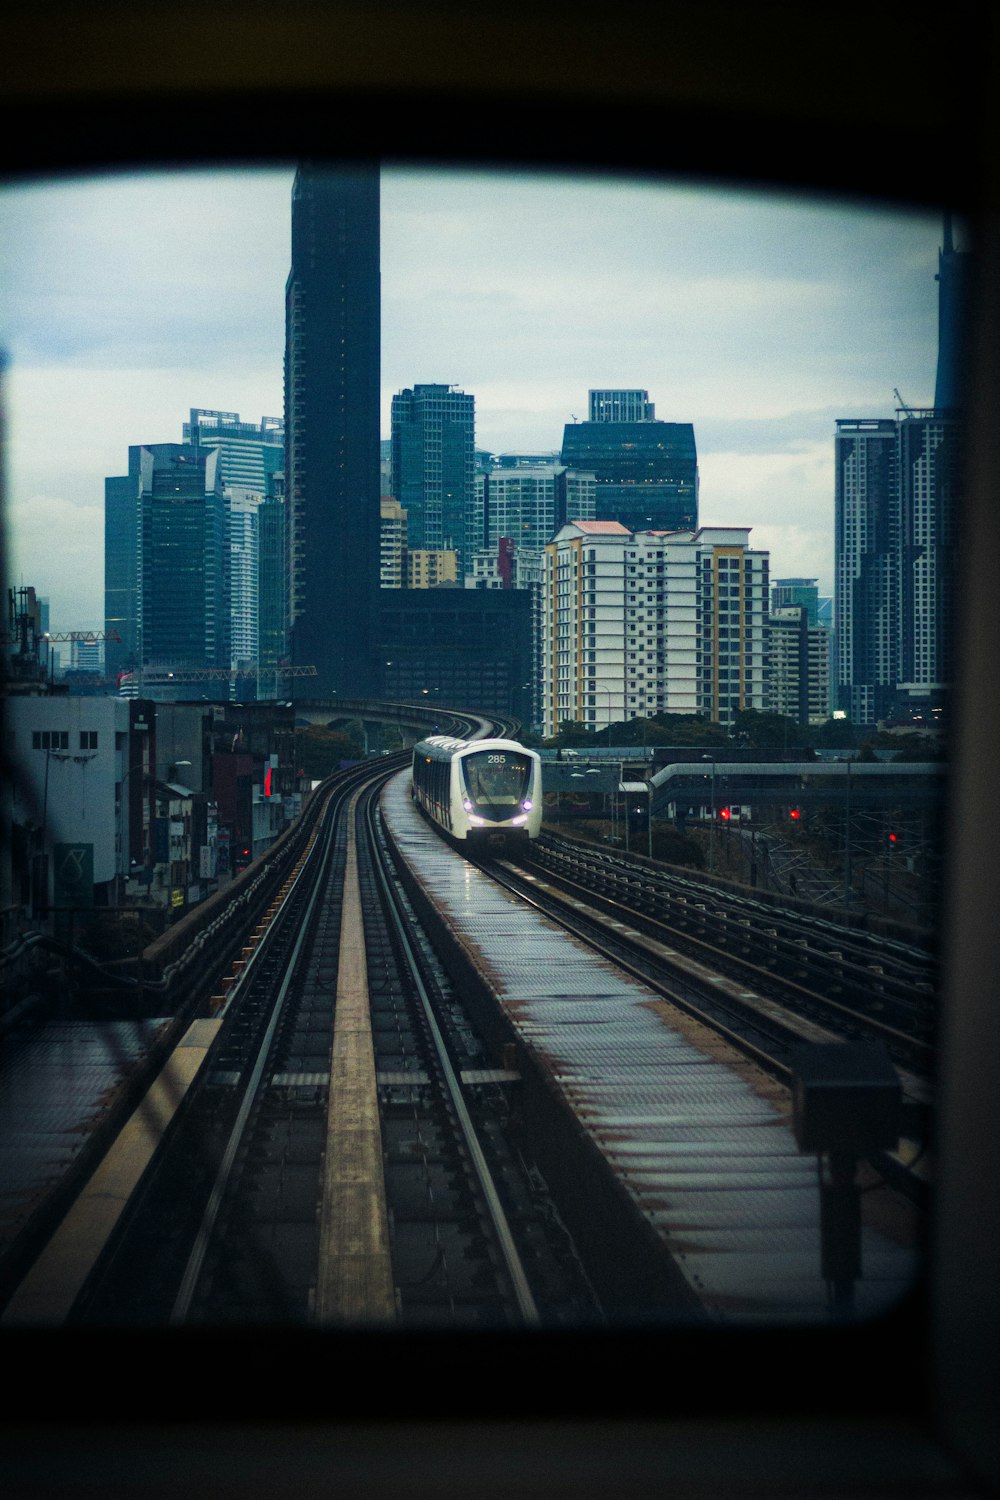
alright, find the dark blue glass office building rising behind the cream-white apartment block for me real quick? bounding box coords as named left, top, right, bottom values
left=561, top=392, right=699, bottom=531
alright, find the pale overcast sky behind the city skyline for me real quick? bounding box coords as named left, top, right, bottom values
left=0, top=170, right=940, bottom=630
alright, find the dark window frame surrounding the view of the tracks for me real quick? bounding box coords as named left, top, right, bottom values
left=0, top=5, right=1000, bottom=1481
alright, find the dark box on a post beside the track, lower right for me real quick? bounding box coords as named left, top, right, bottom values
left=792, top=1041, right=903, bottom=1155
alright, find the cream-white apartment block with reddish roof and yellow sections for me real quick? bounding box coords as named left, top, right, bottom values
left=541, top=521, right=769, bottom=737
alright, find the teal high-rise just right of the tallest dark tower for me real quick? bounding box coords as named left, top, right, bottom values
left=391, top=386, right=475, bottom=566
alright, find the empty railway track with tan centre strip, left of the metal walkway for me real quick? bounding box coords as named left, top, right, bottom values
left=46, top=762, right=600, bottom=1328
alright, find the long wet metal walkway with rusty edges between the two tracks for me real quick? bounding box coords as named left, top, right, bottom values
left=384, top=774, right=916, bottom=1322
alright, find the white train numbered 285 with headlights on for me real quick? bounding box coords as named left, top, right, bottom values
left=412, top=735, right=541, bottom=848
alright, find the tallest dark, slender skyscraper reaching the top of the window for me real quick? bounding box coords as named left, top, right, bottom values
left=285, top=165, right=381, bottom=698
